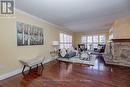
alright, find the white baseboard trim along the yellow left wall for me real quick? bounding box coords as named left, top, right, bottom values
left=0, top=58, right=55, bottom=81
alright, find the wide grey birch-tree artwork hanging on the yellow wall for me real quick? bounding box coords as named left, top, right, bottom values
left=16, top=22, right=44, bottom=46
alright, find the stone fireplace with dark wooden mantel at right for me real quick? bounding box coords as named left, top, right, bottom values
left=104, top=39, right=130, bottom=67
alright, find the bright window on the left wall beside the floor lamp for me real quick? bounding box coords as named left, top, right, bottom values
left=60, top=33, right=72, bottom=49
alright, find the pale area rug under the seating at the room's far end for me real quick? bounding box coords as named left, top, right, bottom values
left=57, top=55, right=96, bottom=65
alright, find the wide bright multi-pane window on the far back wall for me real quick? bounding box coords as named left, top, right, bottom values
left=81, top=35, right=106, bottom=49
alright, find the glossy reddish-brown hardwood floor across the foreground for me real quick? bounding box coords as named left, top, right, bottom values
left=0, top=58, right=130, bottom=87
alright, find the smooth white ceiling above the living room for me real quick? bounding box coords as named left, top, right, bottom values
left=16, top=0, right=130, bottom=32
